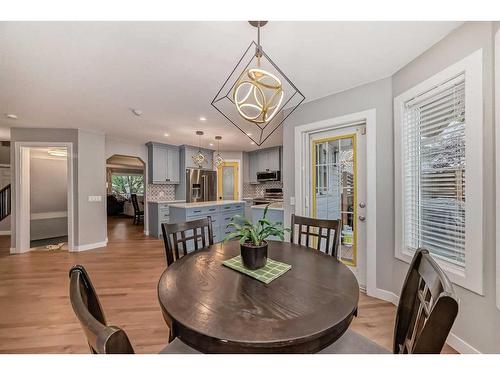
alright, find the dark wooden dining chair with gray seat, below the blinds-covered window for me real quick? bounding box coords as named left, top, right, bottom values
left=320, top=249, right=458, bottom=354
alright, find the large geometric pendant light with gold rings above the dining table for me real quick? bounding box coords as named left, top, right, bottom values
left=212, top=21, right=305, bottom=146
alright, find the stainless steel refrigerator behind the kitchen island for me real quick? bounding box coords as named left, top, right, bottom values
left=186, top=169, right=217, bottom=203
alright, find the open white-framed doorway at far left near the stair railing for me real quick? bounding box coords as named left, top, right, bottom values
left=11, top=142, right=74, bottom=253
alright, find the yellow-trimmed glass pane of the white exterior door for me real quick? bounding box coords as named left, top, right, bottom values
left=312, top=135, right=356, bottom=266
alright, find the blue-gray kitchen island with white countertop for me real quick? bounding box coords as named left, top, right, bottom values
left=169, top=200, right=245, bottom=243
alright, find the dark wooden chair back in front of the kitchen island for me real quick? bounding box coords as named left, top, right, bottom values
left=161, top=216, right=214, bottom=266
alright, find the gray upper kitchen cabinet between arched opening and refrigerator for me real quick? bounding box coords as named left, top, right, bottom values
left=146, top=142, right=180, bottom=184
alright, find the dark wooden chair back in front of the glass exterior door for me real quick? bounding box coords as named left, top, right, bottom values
left=290, top=214, right=341, bottom=258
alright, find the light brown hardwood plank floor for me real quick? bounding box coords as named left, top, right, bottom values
left=0, top=218, right=454, bottom=353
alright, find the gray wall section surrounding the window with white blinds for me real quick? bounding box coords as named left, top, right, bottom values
left=393, top=22, right=500, bottom=353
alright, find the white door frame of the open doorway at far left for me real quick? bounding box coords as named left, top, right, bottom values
left=11, top=142, right=74, bottom=254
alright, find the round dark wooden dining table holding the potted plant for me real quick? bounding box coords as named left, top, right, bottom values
left=158, top=241, right=359, bottom=353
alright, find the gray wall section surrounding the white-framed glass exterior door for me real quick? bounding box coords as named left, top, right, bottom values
left=283, top=78, right=394, bottom=290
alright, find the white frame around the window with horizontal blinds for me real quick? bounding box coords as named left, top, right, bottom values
left=394, top=49, right=483, bottom=295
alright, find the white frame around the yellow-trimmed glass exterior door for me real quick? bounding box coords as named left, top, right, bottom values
left=295, top=108, right=378, bottom=296
